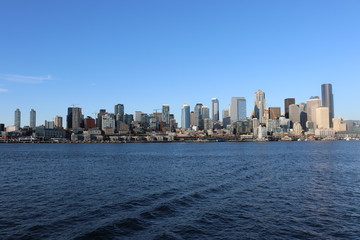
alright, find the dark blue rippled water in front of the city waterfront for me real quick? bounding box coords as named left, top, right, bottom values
left=0, top=141, right=360, bottom=239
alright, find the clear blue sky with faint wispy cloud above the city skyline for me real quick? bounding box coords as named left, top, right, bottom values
left=0, top=0, right=360, bottom=125
